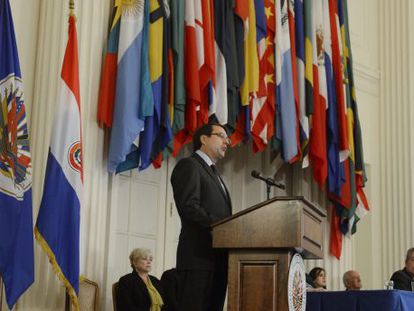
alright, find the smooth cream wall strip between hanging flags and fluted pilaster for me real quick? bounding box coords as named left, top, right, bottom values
left=348, top=0, right=383, bottom=288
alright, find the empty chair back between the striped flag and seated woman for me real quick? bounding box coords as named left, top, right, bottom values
left=65, top=278, right=99, bottom=311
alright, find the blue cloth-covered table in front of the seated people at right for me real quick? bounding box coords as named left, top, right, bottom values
left=306, top=290, right=414, bottom=311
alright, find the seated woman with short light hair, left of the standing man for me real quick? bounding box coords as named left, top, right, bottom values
left=116, top=248, right=165, bottom=311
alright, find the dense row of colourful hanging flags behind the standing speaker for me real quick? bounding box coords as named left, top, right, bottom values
left=98, top=0, right=368, bottom=258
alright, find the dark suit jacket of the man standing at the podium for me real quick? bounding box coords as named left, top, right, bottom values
left=171, top=153, right=231, bottom=270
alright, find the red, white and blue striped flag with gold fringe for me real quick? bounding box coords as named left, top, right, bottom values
left=35, top=15, right=83, bottom=310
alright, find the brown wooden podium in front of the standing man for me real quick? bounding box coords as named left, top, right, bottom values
left=212, top=197, right=326, bottom=311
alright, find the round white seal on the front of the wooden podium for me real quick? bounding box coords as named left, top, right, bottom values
left=288, top=254, right=306, bottom=311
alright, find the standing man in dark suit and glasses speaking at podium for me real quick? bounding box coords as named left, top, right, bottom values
left=171, top=124, right=231, bottom=311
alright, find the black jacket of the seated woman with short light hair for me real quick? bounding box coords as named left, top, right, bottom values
left=116, top=271, right=165, bottom=311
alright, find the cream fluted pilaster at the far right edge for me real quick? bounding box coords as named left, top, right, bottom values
left=379, top=0, right=414, bottom=286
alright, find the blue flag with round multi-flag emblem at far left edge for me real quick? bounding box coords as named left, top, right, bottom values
left=0, top=0, right=34, bottom=309
